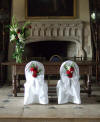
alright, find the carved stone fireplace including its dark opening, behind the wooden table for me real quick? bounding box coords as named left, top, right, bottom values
left=22, top=21, right=92, bottom=60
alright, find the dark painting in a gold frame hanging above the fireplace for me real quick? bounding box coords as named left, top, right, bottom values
left=26, top=0, right=76, bottom=19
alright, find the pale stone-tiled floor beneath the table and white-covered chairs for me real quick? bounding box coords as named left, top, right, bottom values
left=0, top=86, right=100, bottom=122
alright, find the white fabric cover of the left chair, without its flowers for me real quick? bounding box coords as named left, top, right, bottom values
left=24, top=61, right=48, bottom=105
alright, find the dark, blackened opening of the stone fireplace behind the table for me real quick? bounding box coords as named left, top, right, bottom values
left=24, top=40, right=76, bottom=60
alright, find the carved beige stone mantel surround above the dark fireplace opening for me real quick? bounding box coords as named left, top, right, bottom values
left=26, top=20, right=85, bottom=57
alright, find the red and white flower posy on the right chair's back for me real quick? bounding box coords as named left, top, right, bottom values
left=64, top=64, right=74, bottom=78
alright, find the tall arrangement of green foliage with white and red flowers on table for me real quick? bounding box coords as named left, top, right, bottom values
left=9, top=17, right=31, bottom=63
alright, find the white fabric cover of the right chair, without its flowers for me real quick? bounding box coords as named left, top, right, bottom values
left=57, top=60, right=81, bottom=104
